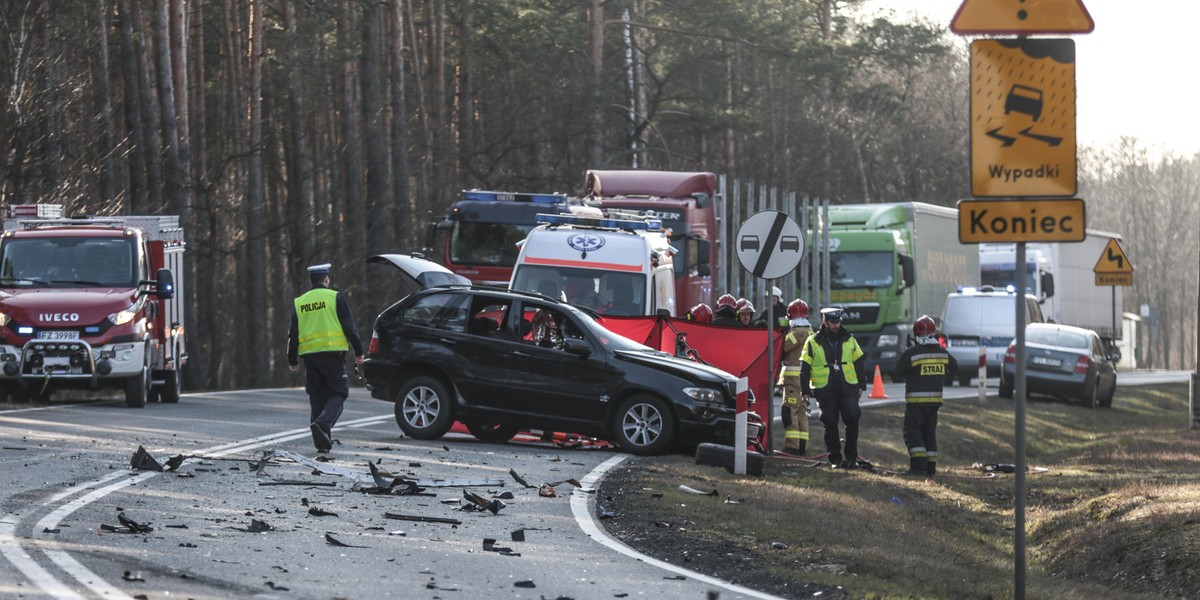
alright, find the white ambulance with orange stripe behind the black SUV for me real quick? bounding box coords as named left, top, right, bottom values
left=509, top=214, right=677, bottom=317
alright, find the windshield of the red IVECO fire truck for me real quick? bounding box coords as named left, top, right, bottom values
left=0, top=236, right=139, bottom=288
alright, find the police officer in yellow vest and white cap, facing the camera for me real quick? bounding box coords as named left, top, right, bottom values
left=800, top=307, right=868, bottom=469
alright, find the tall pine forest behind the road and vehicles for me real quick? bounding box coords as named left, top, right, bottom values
left=0, top=0, right=1200, bottom=390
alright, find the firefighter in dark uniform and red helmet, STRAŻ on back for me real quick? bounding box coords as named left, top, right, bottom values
left=892, top=314, right=959, bottom=476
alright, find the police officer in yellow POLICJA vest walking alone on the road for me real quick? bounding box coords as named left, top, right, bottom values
left=288, top=263, right=362, bottom=452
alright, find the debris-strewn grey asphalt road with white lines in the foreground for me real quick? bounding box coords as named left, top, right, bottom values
left=0, top=389, right=770, bottom=599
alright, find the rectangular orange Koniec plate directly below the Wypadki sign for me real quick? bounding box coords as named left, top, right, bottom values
left=959, top=198, right=1087, bottom=244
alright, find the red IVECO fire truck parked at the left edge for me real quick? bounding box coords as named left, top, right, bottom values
left=0, top=205, right=187, bottom=408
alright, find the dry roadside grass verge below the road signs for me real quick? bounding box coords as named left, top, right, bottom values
left=600, top=384, right=1200, bottom=599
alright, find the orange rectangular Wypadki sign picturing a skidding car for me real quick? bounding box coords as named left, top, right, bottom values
left=971, top=38, right=1076, bottom=198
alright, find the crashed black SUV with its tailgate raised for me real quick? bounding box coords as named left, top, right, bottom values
left=364, top=254, right=761, bottom=455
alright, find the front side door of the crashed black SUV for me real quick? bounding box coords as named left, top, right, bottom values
left=505, top=301, right=613, bottom=431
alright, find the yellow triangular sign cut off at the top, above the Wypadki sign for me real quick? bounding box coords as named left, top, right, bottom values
left=950, top=0, right=1096, bottom=35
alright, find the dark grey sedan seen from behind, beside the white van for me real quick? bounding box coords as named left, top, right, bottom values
left=1000, top=323, right=1117, bottom=408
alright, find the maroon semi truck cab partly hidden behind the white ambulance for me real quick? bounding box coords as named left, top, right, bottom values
left=584, top=170, right=719, bottom=314
